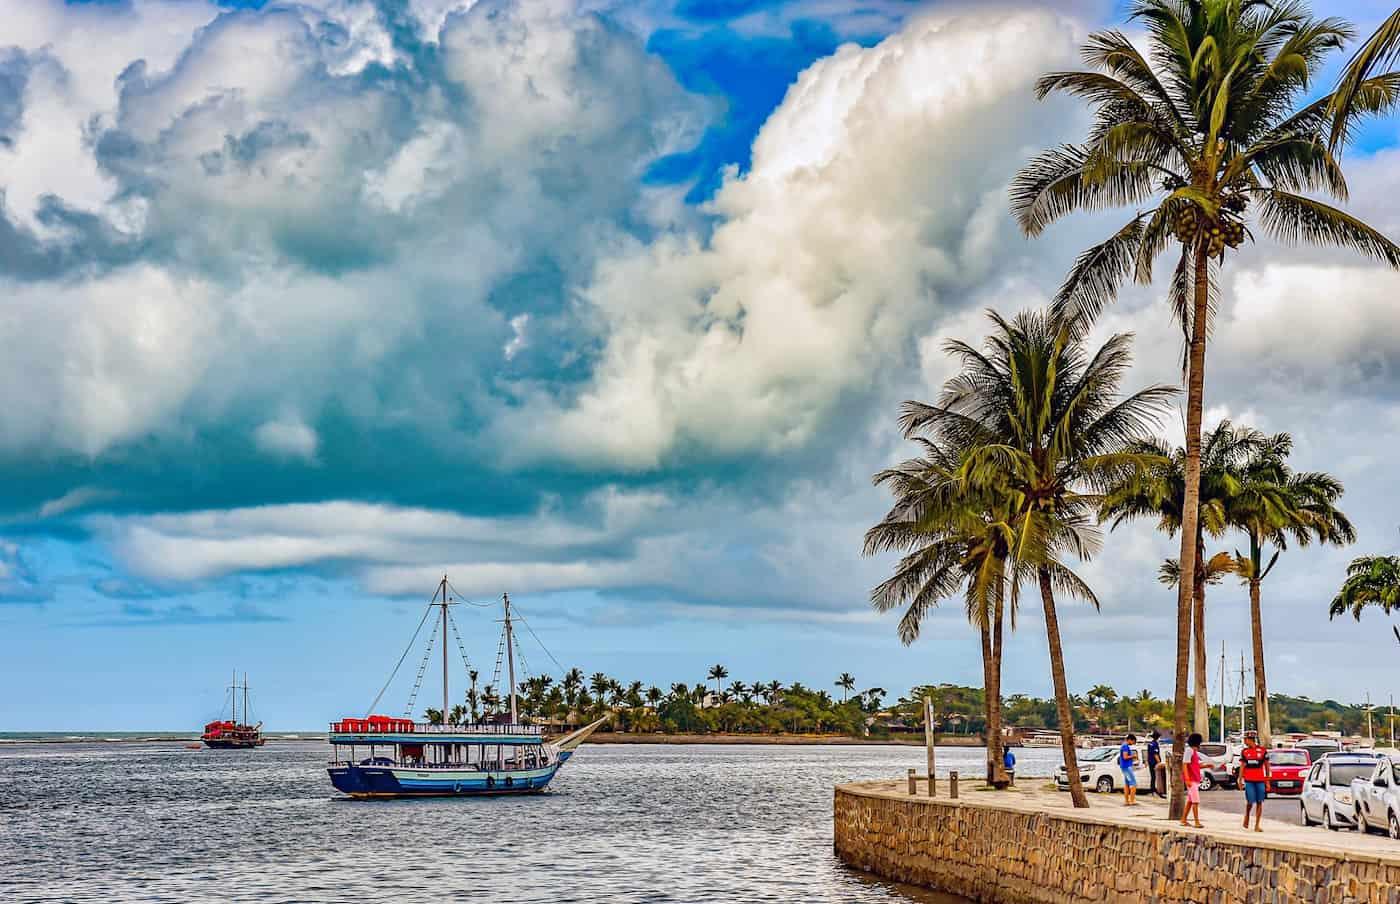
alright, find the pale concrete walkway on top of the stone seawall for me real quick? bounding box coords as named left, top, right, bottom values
left=844, top=775, right=1400, bottom=865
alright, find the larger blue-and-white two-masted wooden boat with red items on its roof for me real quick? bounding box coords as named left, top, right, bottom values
left=326, top=577, right=606, bottom=798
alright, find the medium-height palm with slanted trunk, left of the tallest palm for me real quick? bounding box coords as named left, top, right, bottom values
left=884, top=312, right=1175, bottom=806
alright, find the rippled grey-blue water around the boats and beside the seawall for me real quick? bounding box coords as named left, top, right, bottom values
left=0, top=742, right=1058, bottom=904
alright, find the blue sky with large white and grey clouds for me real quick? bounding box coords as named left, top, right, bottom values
left=0, top=0, right=1400, bottom=730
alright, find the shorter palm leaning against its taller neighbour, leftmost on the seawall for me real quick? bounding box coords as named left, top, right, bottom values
left=856, top=431, right=1015, bottom=785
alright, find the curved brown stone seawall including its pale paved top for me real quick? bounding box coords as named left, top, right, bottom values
left=836, top=782, right=1400, bottom=904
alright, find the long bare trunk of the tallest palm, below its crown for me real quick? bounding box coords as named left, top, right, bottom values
left=1166, top=242, right=1211, bottom=820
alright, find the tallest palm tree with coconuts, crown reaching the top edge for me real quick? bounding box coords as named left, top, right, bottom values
left=1011, top=0, right=1400, bottom=816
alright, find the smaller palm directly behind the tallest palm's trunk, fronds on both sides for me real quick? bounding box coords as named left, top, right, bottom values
left=1099, top=421, right=1267, bottom=735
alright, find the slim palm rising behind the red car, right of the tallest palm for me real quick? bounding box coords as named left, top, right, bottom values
left=1228, top=434, right=1357, bottom=746
